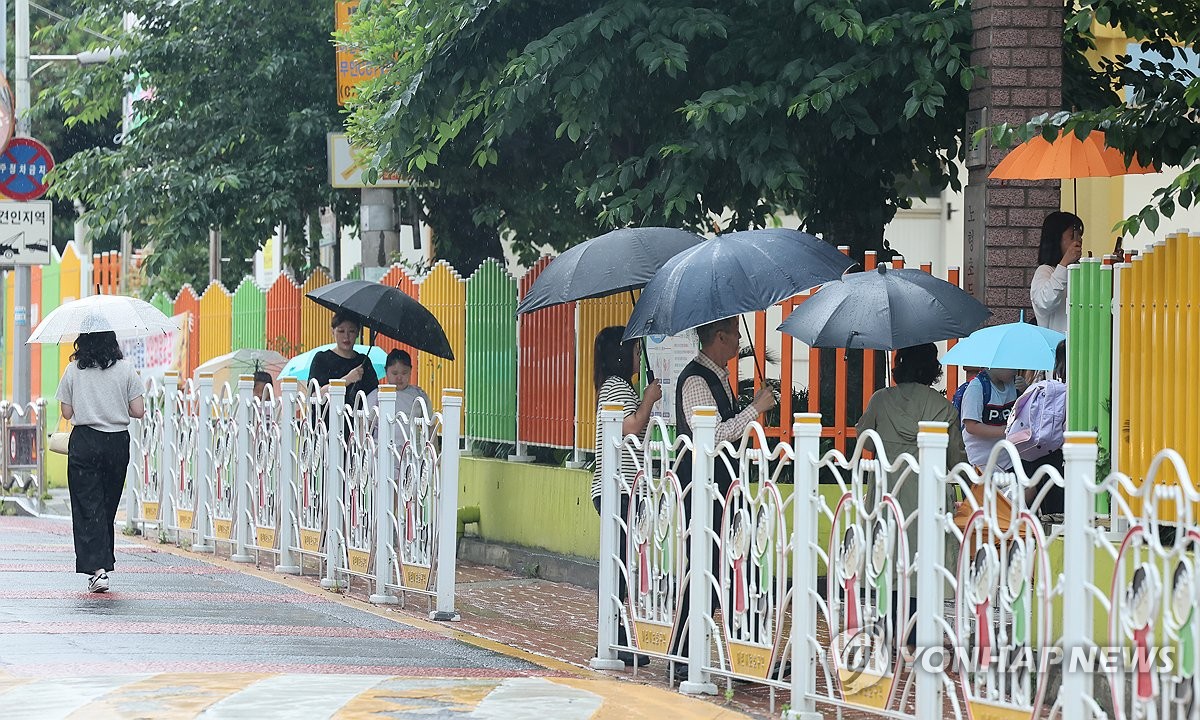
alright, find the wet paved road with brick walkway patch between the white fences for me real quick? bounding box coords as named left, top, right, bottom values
left=0, top=517, right=757, bottom=720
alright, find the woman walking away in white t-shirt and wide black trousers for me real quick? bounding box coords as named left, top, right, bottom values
left=56, top=332, right=145, bottom=593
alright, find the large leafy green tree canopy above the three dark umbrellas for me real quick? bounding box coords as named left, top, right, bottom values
left=343, top=0, right=977, bottom=259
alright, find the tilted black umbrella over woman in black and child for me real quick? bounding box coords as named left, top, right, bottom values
left=308, top=280, right=454, bottom=360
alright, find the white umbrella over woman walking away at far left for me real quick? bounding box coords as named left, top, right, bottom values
left=26, top=295, right=179, bottom=344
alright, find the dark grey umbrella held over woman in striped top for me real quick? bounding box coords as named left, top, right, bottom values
left=517, top=228, right=704, bottom=314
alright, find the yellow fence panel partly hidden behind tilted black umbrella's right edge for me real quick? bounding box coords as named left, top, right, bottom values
left=419, top=262, right=467, bottom=410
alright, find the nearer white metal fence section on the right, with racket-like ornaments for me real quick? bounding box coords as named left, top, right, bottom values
left=593, top=406, right=1200, bottom=720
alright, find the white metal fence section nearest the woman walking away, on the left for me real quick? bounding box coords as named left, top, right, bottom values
left=126, top=373, right=462, bottom=619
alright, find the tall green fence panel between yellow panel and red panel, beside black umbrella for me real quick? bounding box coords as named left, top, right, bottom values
left=460, top=260, right=517, bottom=443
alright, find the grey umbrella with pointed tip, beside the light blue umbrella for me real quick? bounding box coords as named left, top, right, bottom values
left=779, top=265, right=991, bottom=350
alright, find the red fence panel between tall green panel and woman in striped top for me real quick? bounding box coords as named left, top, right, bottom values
left=513, top=257, right=573, bottom=448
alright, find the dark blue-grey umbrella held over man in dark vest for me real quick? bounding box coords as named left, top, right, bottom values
left=625, top=229, right=853, bottom=340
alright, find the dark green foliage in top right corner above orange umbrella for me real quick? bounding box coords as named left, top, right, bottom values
left=991, top=0, right=1200, bottom=234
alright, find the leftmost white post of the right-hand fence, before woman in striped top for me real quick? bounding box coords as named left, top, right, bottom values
left=590, top=402, right=625, bottom=670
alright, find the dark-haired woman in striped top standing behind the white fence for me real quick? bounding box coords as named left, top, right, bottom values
left=592, top=325, right=662, bottom=667
